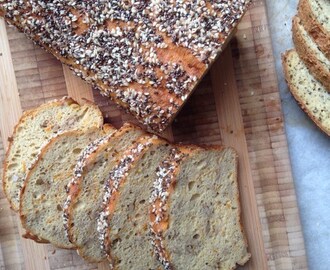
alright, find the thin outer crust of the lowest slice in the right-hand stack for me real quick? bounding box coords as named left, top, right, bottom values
left=282, top=49, right=330, bottom=136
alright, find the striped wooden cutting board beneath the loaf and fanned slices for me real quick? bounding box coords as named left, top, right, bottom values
left=0, top=0, right=307, bottom=270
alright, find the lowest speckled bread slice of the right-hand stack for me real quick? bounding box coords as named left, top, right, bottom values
left=282, top=50, right=330, bottom=136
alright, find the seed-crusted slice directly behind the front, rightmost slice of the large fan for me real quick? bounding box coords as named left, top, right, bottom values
left=98, top=137, right=173, bottom=269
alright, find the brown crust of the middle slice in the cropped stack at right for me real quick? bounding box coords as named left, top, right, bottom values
left=292, top=16, right=330, bottom=92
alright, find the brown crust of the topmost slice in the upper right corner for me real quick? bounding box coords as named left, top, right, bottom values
left=298, top=0, right=330, bottom=59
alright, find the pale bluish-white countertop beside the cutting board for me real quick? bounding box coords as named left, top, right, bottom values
left=266, top=0, right=330, bottom=270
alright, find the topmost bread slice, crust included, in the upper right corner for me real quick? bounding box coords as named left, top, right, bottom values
left=298, top=0, right=330, bottom=59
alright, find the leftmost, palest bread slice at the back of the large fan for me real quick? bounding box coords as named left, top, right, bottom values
left=3, top=97, right=103, bottom=211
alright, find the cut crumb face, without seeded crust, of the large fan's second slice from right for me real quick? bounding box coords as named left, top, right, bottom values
left=106, top=138, right=173, bottom=269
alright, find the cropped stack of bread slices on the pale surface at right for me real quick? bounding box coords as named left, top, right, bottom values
left=282, top=0, right=330, bottom=136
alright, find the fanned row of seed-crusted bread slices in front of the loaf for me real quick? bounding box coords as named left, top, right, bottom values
left=3, top=98, right=250, bottom=269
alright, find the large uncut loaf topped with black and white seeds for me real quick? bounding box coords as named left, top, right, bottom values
left=0, top=0, right=250, bottom=132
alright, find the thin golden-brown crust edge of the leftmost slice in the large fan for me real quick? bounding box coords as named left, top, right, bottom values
left=2, top=97, right=78, bottom=212
